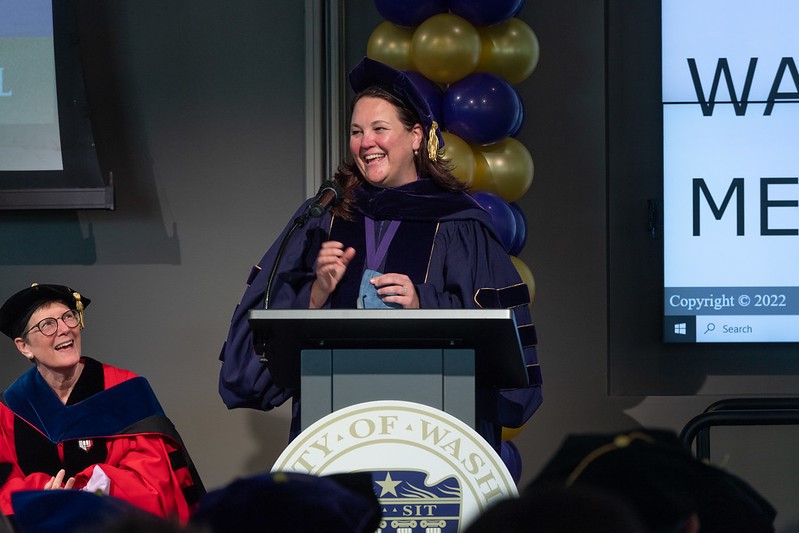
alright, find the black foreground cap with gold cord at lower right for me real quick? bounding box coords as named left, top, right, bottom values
left=525, top=429, right=776, bottom=533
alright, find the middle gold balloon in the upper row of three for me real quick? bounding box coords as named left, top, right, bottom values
left=411, top=13, right=480, bottom=83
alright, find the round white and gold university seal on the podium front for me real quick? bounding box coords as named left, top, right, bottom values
left=272, top=401, right=518, bottom=533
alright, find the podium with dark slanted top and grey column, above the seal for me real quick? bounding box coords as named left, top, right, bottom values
left=249, top=309, right=528, bottom=430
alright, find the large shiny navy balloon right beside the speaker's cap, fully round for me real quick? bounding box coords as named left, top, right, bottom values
left=442, top=72, right=521, bottom=144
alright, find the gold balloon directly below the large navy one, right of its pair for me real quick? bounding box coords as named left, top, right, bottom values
left=472, top=137, right=535, bottom=202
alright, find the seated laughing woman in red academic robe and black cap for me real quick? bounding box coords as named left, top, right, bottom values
left=0, top=284, right=204, bottom=523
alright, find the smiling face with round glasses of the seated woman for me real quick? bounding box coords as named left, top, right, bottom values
left=15, top=302, right=81, bottom=371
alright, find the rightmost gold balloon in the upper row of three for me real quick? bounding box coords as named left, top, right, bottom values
left=476, top=18, right=540, bottom=84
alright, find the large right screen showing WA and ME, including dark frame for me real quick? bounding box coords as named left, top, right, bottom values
left=605, top=0, right=799, bottom=396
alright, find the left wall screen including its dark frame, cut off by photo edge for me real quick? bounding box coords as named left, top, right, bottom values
left=0, top=0, right=113, bottom=209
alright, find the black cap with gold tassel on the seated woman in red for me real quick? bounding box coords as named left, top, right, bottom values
left=0, top=283, right=91, bottom=339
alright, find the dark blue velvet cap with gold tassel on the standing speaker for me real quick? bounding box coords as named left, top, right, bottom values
left=350, top=57, right=444, bottom=161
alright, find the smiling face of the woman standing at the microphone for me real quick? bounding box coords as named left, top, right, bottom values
left=350, top=96, right=422, bottom=187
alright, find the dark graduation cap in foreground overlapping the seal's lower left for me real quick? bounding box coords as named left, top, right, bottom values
left=191, top=472, right=382, bottom=533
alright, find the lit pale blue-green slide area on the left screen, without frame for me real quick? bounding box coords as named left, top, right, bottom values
left=0, top=0, right=63, bottom=171
